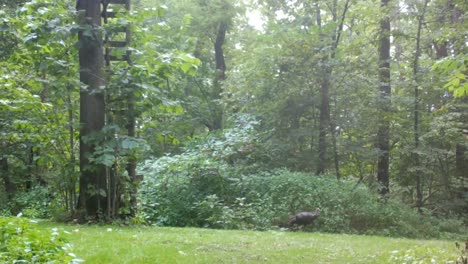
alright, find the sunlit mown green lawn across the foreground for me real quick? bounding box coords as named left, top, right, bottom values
left=41, top=223, right=459, bottom=263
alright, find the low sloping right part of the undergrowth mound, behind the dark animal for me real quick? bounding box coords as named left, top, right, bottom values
left=244, top=170, right=466, bottom=237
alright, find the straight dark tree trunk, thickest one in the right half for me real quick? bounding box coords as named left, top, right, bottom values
left=377, top=0, right=391, bottom=196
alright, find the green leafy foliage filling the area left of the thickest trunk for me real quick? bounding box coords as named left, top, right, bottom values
left=0, top=0, right=80, bottom=217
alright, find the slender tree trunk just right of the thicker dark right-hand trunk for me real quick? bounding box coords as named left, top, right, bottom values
left=413, top=0, right=429, bottom=212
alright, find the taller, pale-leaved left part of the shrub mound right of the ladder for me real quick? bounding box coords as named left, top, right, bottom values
left=139, top=116, right=264, bottom=228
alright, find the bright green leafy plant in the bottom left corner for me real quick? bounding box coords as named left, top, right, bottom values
left=0, top=217, right=82, bottom=263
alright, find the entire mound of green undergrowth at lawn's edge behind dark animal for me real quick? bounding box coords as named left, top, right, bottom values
left=139, top=116, right=464, bottom=237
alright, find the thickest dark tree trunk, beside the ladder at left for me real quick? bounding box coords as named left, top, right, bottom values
left=77, top=0, right=108, bottom=218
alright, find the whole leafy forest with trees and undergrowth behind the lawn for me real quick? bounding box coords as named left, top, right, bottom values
left=0, top=0, right=468, bottom=261
